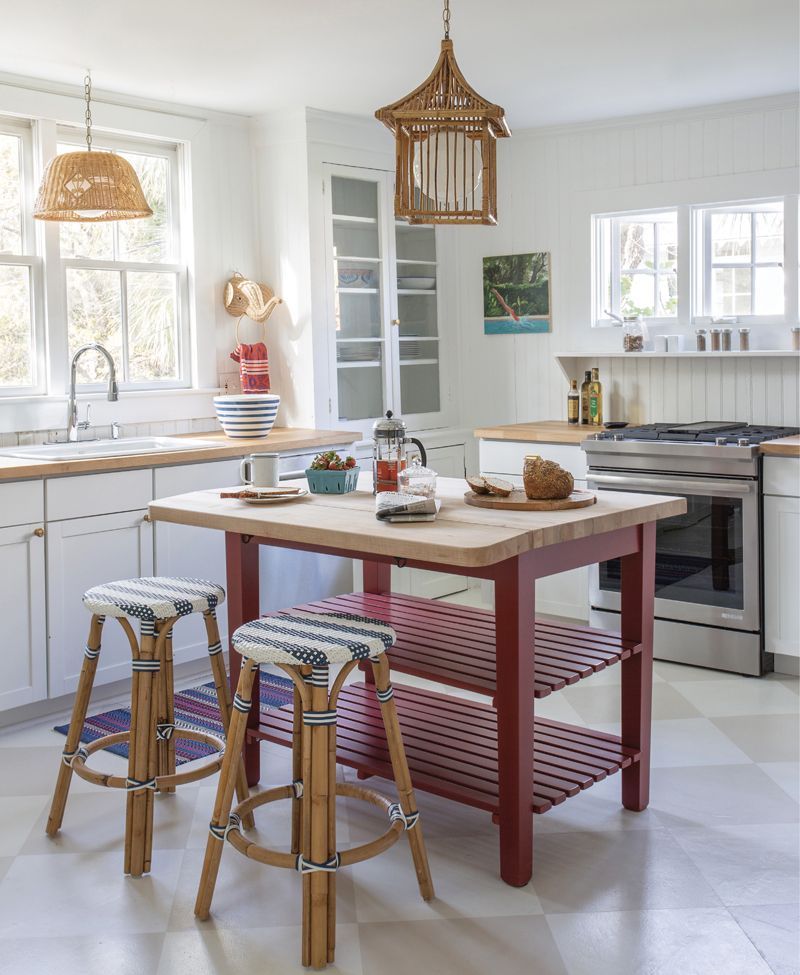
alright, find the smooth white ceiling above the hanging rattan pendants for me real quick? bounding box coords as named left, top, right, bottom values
left=0, top=0, right=798, bottom=129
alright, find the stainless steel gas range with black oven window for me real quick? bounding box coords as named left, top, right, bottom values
left=581, top=422, right=800, bottom=675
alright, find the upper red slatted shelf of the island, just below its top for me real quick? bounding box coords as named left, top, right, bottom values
left=294, top=592, right=641, bottom=698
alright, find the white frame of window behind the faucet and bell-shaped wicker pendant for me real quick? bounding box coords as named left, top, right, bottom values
left=55, top=125, right=192, bottom=393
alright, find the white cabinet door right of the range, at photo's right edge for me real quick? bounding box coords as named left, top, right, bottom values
left=764, top=496, right=800, bottom=657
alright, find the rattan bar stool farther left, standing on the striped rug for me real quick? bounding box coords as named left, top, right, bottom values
left=46, top=577, right=248, bottom=877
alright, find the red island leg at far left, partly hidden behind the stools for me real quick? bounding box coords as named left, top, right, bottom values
left=225, top=532, right=261, bottom=787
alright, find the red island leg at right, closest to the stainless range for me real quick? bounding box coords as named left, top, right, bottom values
left=620, top=522, right=656, bottom=812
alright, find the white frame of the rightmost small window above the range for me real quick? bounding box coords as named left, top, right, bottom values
left=692, top=196, right=789, bottom=325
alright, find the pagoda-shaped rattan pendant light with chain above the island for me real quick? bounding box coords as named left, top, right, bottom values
left=375, top=0, right=511, bottom=224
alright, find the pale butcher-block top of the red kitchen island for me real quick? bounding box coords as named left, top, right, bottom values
left=149, top=473, right=686, bottom=568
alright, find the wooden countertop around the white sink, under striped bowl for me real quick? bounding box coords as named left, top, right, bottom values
left=0, top=427, right=362, bottom=481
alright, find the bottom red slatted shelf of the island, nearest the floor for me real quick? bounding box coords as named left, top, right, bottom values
left=251, top=683, right=639, bottom=814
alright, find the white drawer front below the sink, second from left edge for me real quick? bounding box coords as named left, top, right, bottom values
left=45, top=468, right=153, bottom=521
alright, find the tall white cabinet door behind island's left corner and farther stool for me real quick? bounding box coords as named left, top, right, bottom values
left=153, top=457, right=240, bottom=663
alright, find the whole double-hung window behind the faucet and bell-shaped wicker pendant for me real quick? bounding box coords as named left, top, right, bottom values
left=58, top=131, right=188, bottom=388
